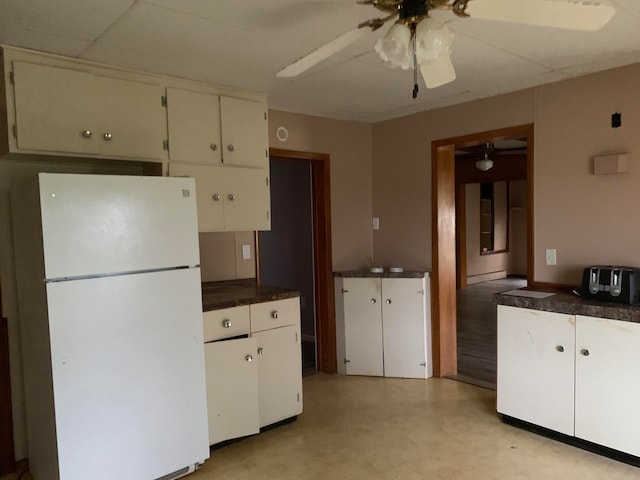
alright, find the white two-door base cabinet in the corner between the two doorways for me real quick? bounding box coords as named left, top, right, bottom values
left=335, top=276, right=432, bottom=378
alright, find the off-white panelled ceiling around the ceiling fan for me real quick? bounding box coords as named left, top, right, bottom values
left=0, top=0, right=640, bottom=122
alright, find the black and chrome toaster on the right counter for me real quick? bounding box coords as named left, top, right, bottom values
left=582, top=266, right=640, bottom=304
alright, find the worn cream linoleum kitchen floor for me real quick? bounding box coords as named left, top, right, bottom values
left=1, top=374, right=640, bottom=480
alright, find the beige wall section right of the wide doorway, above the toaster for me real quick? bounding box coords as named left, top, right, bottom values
left=535, top=64, right=640, bottom=285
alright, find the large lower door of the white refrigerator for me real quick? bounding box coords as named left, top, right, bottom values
left=47, top=268, right=209, bottom=480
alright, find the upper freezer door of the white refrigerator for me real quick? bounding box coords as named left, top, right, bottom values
left=39, top=173, right=200, bottom=279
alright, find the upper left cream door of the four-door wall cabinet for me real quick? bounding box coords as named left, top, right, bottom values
left=167, top=88, right=222, bottom=165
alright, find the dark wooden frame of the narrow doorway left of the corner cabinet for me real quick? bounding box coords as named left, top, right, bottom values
left=269, top=148, right=337, bottom=373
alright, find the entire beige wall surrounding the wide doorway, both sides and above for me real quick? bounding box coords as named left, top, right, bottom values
left=372, top=64, right=640, bottom=285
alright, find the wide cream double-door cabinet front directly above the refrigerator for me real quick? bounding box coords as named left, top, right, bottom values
left=12, top=61, right=166, bottom=161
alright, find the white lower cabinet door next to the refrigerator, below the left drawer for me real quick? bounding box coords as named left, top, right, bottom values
left=204, top=338, right=259, bottom=445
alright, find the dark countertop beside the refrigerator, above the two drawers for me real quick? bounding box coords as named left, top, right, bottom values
left=202, top=279, right=300, bottom=312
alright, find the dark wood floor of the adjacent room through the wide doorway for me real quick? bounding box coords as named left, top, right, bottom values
left=456, top=278, right=527, bottom=390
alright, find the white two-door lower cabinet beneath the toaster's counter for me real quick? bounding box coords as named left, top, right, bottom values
left=497, top=305, right=640, bottom=456
